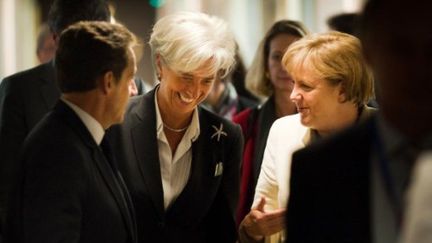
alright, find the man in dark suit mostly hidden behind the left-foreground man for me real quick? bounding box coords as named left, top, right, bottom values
left=0, top=0, right=110, bottom=228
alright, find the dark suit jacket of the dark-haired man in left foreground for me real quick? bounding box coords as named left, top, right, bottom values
left=6, top=101, right=136, bottom=243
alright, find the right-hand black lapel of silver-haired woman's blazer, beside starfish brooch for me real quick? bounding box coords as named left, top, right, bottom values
left=167, top=108, right=221, bottom=225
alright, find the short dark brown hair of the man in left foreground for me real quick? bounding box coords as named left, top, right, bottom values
left=55, top=21, right=136, bottom=93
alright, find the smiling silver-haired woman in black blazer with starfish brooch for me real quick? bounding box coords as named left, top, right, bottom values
left=106, top=12, right=243, bottom=243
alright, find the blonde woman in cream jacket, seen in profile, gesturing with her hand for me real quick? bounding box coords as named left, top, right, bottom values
left=240, top=31, right=373, bottom=242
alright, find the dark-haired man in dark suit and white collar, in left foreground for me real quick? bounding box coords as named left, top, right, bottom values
left=6, top=21, right=136, bottom=243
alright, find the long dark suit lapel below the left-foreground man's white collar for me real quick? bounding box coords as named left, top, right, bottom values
left=55, top=100, right=135, bottom=241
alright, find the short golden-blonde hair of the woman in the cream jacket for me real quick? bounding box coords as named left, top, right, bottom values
left=282, top=31, right=374, bottom=106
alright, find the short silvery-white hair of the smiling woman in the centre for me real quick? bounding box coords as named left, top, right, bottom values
left=149, top=12, right=236, bottom=77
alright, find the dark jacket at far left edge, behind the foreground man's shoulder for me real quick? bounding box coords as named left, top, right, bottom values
left=0, top=62, right=60, bottom=219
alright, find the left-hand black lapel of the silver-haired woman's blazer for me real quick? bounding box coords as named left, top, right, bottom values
left=126, top=89, right=165, bottom=219
